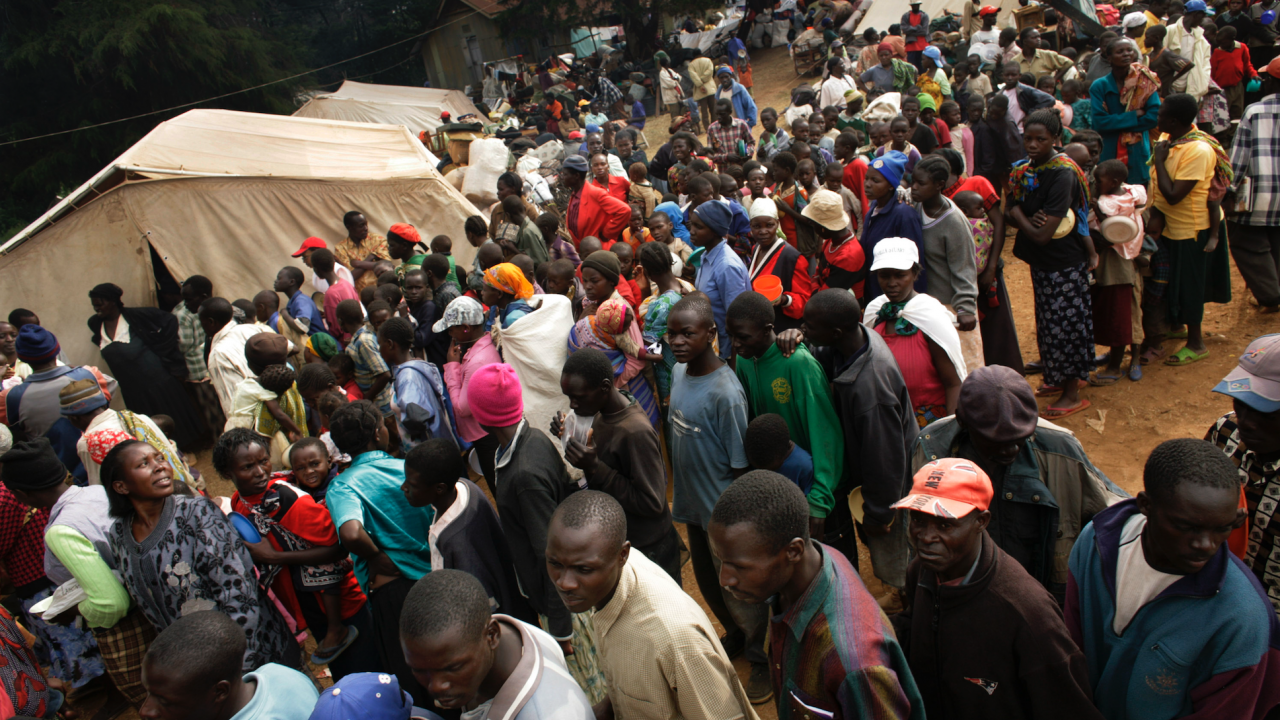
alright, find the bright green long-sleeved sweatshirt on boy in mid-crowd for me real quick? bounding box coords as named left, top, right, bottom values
left=737, top=345, right=845, bottom=518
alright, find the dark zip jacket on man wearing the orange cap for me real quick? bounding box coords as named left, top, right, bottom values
left=893, top=533, right=1102, bottom=720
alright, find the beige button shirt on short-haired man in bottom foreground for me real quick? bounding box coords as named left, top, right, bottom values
left=594, top=548, right=759, bottom=720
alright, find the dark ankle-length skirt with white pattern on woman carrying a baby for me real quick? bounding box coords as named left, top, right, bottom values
left=1032, top=263, right=1096, bottom=387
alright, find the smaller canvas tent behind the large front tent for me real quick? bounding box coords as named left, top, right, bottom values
left=293, top=79, right=484, bottom=135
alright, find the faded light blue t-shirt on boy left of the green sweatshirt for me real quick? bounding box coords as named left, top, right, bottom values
left=669, top=363, right=749, bottom=528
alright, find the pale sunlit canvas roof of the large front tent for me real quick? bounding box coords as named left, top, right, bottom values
left=0, top=110, right=450, bottom=254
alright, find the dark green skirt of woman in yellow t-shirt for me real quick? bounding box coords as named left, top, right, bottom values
left=1160, top=225, right=1231, bottom=325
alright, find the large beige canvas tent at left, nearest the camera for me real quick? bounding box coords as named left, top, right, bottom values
left=0, top=110, right=477, bottom=365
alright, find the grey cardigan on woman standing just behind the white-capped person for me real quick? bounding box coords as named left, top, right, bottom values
left=915, top=197, right=978, bottom=316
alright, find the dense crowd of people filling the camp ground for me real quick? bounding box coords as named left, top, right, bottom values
left=0, top=0, right=1280, bottom=720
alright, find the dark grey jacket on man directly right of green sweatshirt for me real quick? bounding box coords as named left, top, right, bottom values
left=809, top=327, right=921, bottom=525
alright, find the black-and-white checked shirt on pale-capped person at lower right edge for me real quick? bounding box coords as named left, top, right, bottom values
left=1204, top=409, right=1280, bottom=612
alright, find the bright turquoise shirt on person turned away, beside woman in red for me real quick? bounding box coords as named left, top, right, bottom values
left=325, top=450, right=435, bottom=592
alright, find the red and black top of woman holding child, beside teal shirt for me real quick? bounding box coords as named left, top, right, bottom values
left=232, top=471, right=367, bottom=628
